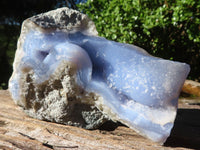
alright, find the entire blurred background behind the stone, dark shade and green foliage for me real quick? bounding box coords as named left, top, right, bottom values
left=0, top=0, right=200, bottom=89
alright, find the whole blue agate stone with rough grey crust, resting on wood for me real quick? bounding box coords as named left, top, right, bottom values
left=9, top=8, right=190, bottom=144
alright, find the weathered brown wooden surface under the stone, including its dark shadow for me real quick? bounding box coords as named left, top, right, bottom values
left=0, top=90, right=200, bottom=150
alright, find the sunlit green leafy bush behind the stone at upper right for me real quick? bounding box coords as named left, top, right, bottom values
left=78, top=0, right=200, bottom=80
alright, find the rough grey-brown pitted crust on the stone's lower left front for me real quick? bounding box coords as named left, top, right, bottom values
left=20, top=62, right=107, bottom=129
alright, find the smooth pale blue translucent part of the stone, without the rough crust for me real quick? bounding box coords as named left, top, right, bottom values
left=10, top=30, right=190, bottom=143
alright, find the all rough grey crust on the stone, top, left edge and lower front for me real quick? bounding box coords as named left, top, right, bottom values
left=10, top=8, right=107, bottom=129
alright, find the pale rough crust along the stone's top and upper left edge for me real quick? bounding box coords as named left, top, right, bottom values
left=10, top=7, right=98, bottom=76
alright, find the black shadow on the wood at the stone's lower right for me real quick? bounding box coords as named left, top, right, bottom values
left=164, top=109, right=200, bottom=149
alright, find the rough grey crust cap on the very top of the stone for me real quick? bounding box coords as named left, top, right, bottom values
left=29, top=7, right=98, bottom=35
